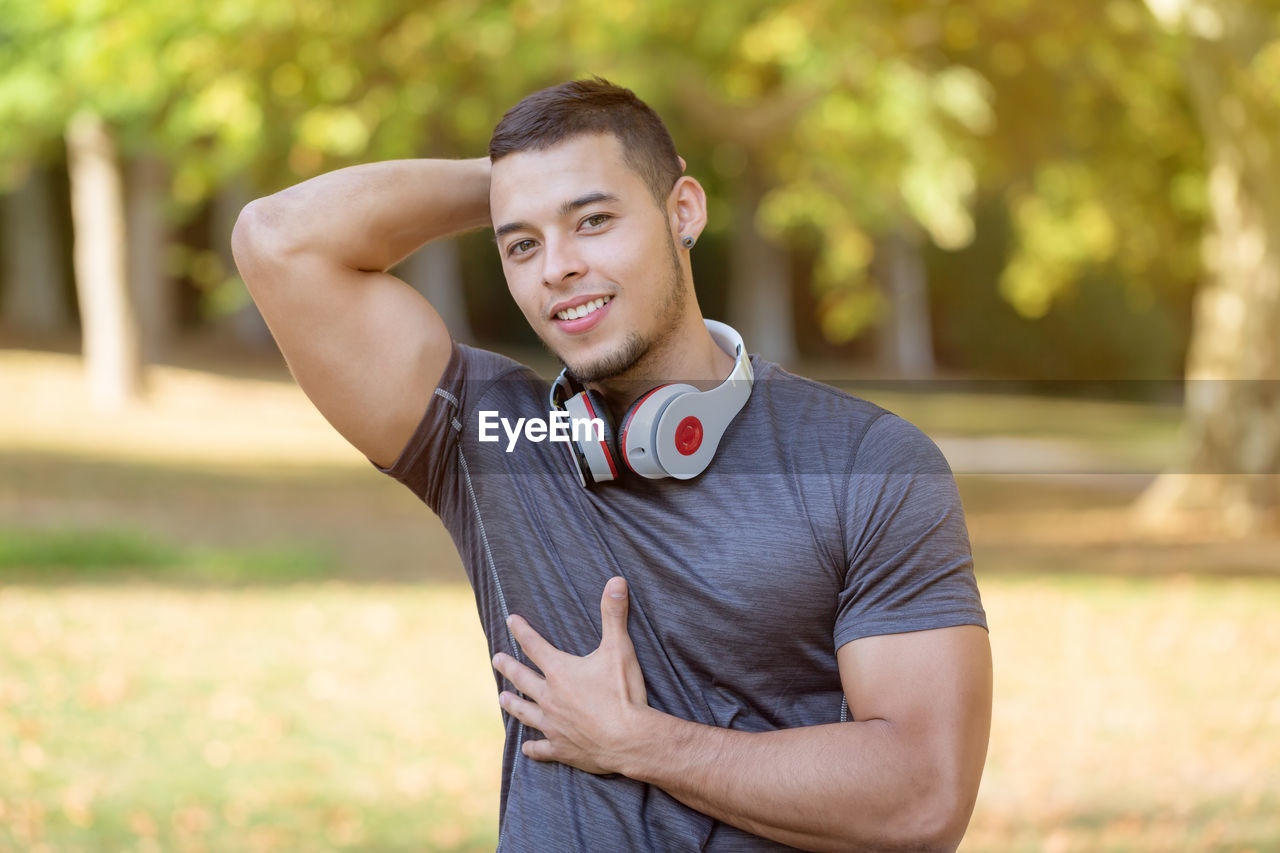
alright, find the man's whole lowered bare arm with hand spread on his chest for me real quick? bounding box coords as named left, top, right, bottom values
left=494, top=589, right=991, bottom=850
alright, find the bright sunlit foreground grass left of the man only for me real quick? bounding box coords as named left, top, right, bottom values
left=0, top=583, right=500, bottom=850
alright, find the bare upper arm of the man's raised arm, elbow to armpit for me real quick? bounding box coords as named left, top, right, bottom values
left=237, top=240, right=452, bottom=467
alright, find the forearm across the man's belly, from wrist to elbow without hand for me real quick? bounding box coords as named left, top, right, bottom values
left=620, top=710, right=972, bottom=850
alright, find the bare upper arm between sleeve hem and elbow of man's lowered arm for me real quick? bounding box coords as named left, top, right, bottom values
left=837, top=625, right=992, bottom=807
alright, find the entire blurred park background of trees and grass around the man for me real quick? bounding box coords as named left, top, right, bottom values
left=0, top=0, right=1280, bottom=853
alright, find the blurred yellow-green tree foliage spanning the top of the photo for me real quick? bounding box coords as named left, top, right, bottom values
left=0, top=0, right=1244, bottom=361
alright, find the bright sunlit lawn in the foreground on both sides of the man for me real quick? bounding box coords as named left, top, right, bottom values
left=0, top=576, right=1280, bottom=850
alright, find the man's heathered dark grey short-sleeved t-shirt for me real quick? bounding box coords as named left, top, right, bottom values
left=385, top=345, right=986, bottom=853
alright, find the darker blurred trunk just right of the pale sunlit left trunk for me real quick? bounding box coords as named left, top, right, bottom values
left=125, top=156, right=178, bottom=364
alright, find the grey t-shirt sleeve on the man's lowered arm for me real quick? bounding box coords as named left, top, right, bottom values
left=835, top=412, right=987, bottom=648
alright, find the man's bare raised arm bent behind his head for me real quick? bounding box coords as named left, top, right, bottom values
left=232, top=158, right=490, bottom=466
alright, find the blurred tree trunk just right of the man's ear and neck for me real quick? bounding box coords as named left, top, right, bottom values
left=727, top=175, right=797, bottom=365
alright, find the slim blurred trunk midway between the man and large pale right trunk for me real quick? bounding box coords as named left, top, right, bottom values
left=874, top=225, right=933, bottom=379
